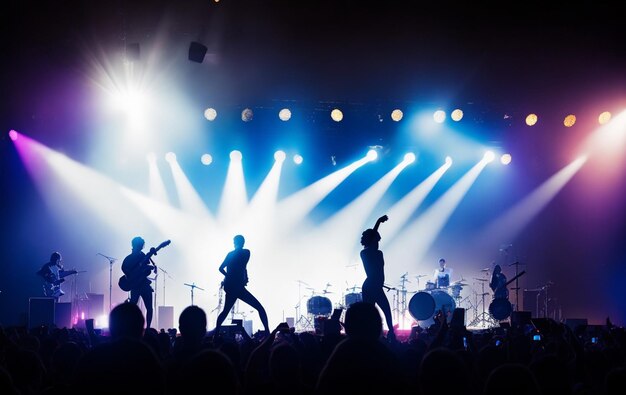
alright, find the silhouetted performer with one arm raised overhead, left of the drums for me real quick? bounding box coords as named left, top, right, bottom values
left=361, top=215, right=395, bottom=339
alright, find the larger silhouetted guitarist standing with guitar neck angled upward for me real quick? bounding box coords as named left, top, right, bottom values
left=122, top=236, right=156, bottom=328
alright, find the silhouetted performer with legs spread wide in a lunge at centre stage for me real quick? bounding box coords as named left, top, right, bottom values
left=215, top=235, right=270, bottom=335
